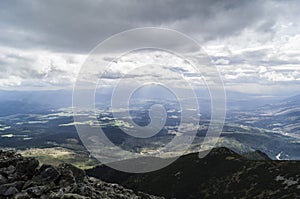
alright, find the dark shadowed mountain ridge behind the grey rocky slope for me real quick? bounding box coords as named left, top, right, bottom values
left=86, top=147, right=300, bottom=199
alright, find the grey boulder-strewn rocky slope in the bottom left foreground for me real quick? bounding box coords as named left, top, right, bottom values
left=0, top=151, right=161, bottom=199
